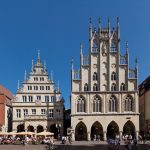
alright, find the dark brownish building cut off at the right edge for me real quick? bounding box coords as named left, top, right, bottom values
left=139, top=76, right=150, bottom=134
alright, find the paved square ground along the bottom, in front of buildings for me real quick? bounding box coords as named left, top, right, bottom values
left=0, top=141, right=150, bottom=150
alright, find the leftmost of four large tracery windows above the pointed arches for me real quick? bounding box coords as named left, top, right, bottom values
left=77, top=96, right=85, bottom=112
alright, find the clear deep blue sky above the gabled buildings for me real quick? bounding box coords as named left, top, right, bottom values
left=0, top=0, right=150, bottom=108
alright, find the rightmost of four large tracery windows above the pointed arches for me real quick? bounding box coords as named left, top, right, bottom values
left=124, top=96, right=133, bottom=111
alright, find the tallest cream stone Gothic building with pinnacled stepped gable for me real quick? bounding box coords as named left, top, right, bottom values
left=71, top=18, right=139, bottom=140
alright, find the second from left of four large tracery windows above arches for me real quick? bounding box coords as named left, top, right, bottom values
left=93, top=95, right=102, bottom=112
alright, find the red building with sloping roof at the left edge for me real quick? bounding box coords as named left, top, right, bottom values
left=0, top=85, right=14, bottom=132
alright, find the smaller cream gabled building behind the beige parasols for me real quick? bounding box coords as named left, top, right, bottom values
left=13, top=51, right=64, bottom=138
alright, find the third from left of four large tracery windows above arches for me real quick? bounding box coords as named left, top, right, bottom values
left=109, top=95, right=117, bottom=112
